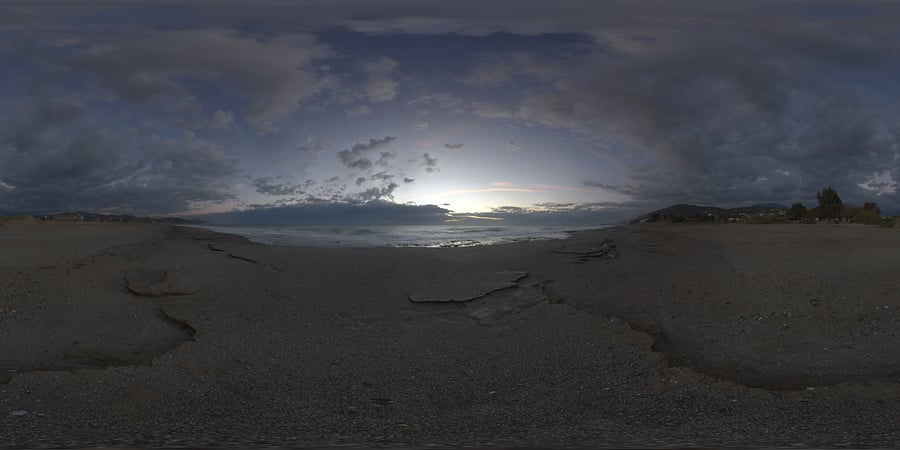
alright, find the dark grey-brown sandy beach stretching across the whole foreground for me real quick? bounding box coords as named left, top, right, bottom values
left=0, top=224, right=900, bottom=447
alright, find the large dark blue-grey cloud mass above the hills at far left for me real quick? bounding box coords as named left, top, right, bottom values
left=0, top=97, right=237, bottom=213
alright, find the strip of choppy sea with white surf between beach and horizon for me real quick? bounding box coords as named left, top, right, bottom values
left=189, top=225, right=611, bottom=247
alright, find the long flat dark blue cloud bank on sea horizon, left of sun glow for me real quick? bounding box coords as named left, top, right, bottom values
left=198, top=201, right=449, bottom=225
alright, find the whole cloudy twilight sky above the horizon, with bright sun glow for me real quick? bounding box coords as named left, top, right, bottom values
left=0, top=0, right=900, bottom=223
